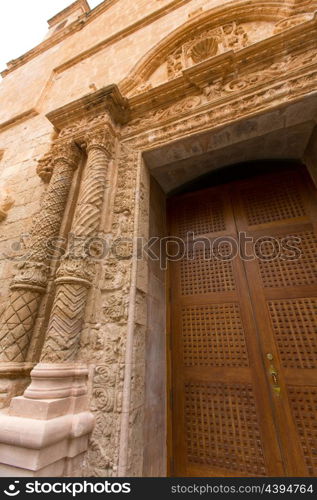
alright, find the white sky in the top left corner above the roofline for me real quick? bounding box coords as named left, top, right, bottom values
left=0, top=0, right=102, bottom=71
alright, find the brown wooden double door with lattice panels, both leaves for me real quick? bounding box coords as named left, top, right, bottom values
left=169, top=167, right=317, bottom=477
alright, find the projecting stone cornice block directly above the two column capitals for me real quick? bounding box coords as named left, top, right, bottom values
left=46, top=85, right=128, bottom=131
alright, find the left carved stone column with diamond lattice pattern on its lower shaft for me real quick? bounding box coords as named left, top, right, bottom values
left=0, top=142, right=80, bottom=362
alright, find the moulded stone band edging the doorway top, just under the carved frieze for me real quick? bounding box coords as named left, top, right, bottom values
left=122, top=67, right=317, bottom=151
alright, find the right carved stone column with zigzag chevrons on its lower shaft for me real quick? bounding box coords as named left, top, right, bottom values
left=41, top=131, right=113, bottom=363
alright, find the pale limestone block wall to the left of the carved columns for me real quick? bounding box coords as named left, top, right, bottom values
left=0, top=116, right=53, bottom=308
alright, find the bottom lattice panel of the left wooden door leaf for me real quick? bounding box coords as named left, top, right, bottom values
left=185, top=382, right=266, bottom=476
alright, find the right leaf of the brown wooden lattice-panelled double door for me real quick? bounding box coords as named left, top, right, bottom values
left=235, top=171, right=317, bottom=476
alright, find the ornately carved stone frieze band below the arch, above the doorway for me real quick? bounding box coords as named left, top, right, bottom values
left=124, top=45, right=317, bottom=143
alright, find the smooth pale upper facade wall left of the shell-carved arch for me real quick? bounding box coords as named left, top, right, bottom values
left=0, top=0, right=233, bottom=126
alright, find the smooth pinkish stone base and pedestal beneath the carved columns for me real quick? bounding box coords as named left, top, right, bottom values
left=0, top=364, right=94, bottom=477
